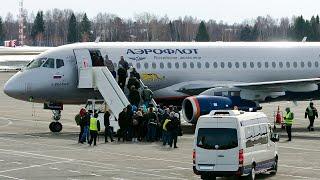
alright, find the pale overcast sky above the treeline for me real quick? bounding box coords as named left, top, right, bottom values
left=0, top=0, right=320, bottom=24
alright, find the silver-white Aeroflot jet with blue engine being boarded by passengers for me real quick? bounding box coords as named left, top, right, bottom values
left=4, top=42, right=320, bottom=131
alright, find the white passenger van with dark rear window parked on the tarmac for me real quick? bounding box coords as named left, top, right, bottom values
left=193, top=110, right=279, bottom=179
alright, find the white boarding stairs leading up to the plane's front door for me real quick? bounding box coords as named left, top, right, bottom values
left=78, top=67, right=157, bottom=118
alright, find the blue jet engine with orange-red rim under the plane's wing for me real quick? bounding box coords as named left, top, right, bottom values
left=182, top=95, right=261, bottom=124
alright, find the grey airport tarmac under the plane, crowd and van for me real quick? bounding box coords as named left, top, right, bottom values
left=0, top=72, right=320, bottom=180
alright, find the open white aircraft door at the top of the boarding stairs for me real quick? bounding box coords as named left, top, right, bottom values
left=73, top=49, right=93, bottom=88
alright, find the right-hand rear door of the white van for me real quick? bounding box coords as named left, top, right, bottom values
left=215, top=122, right=239, bottom=171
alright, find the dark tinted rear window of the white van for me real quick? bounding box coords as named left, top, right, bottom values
left=197, top=128, right=238, bottom=150
